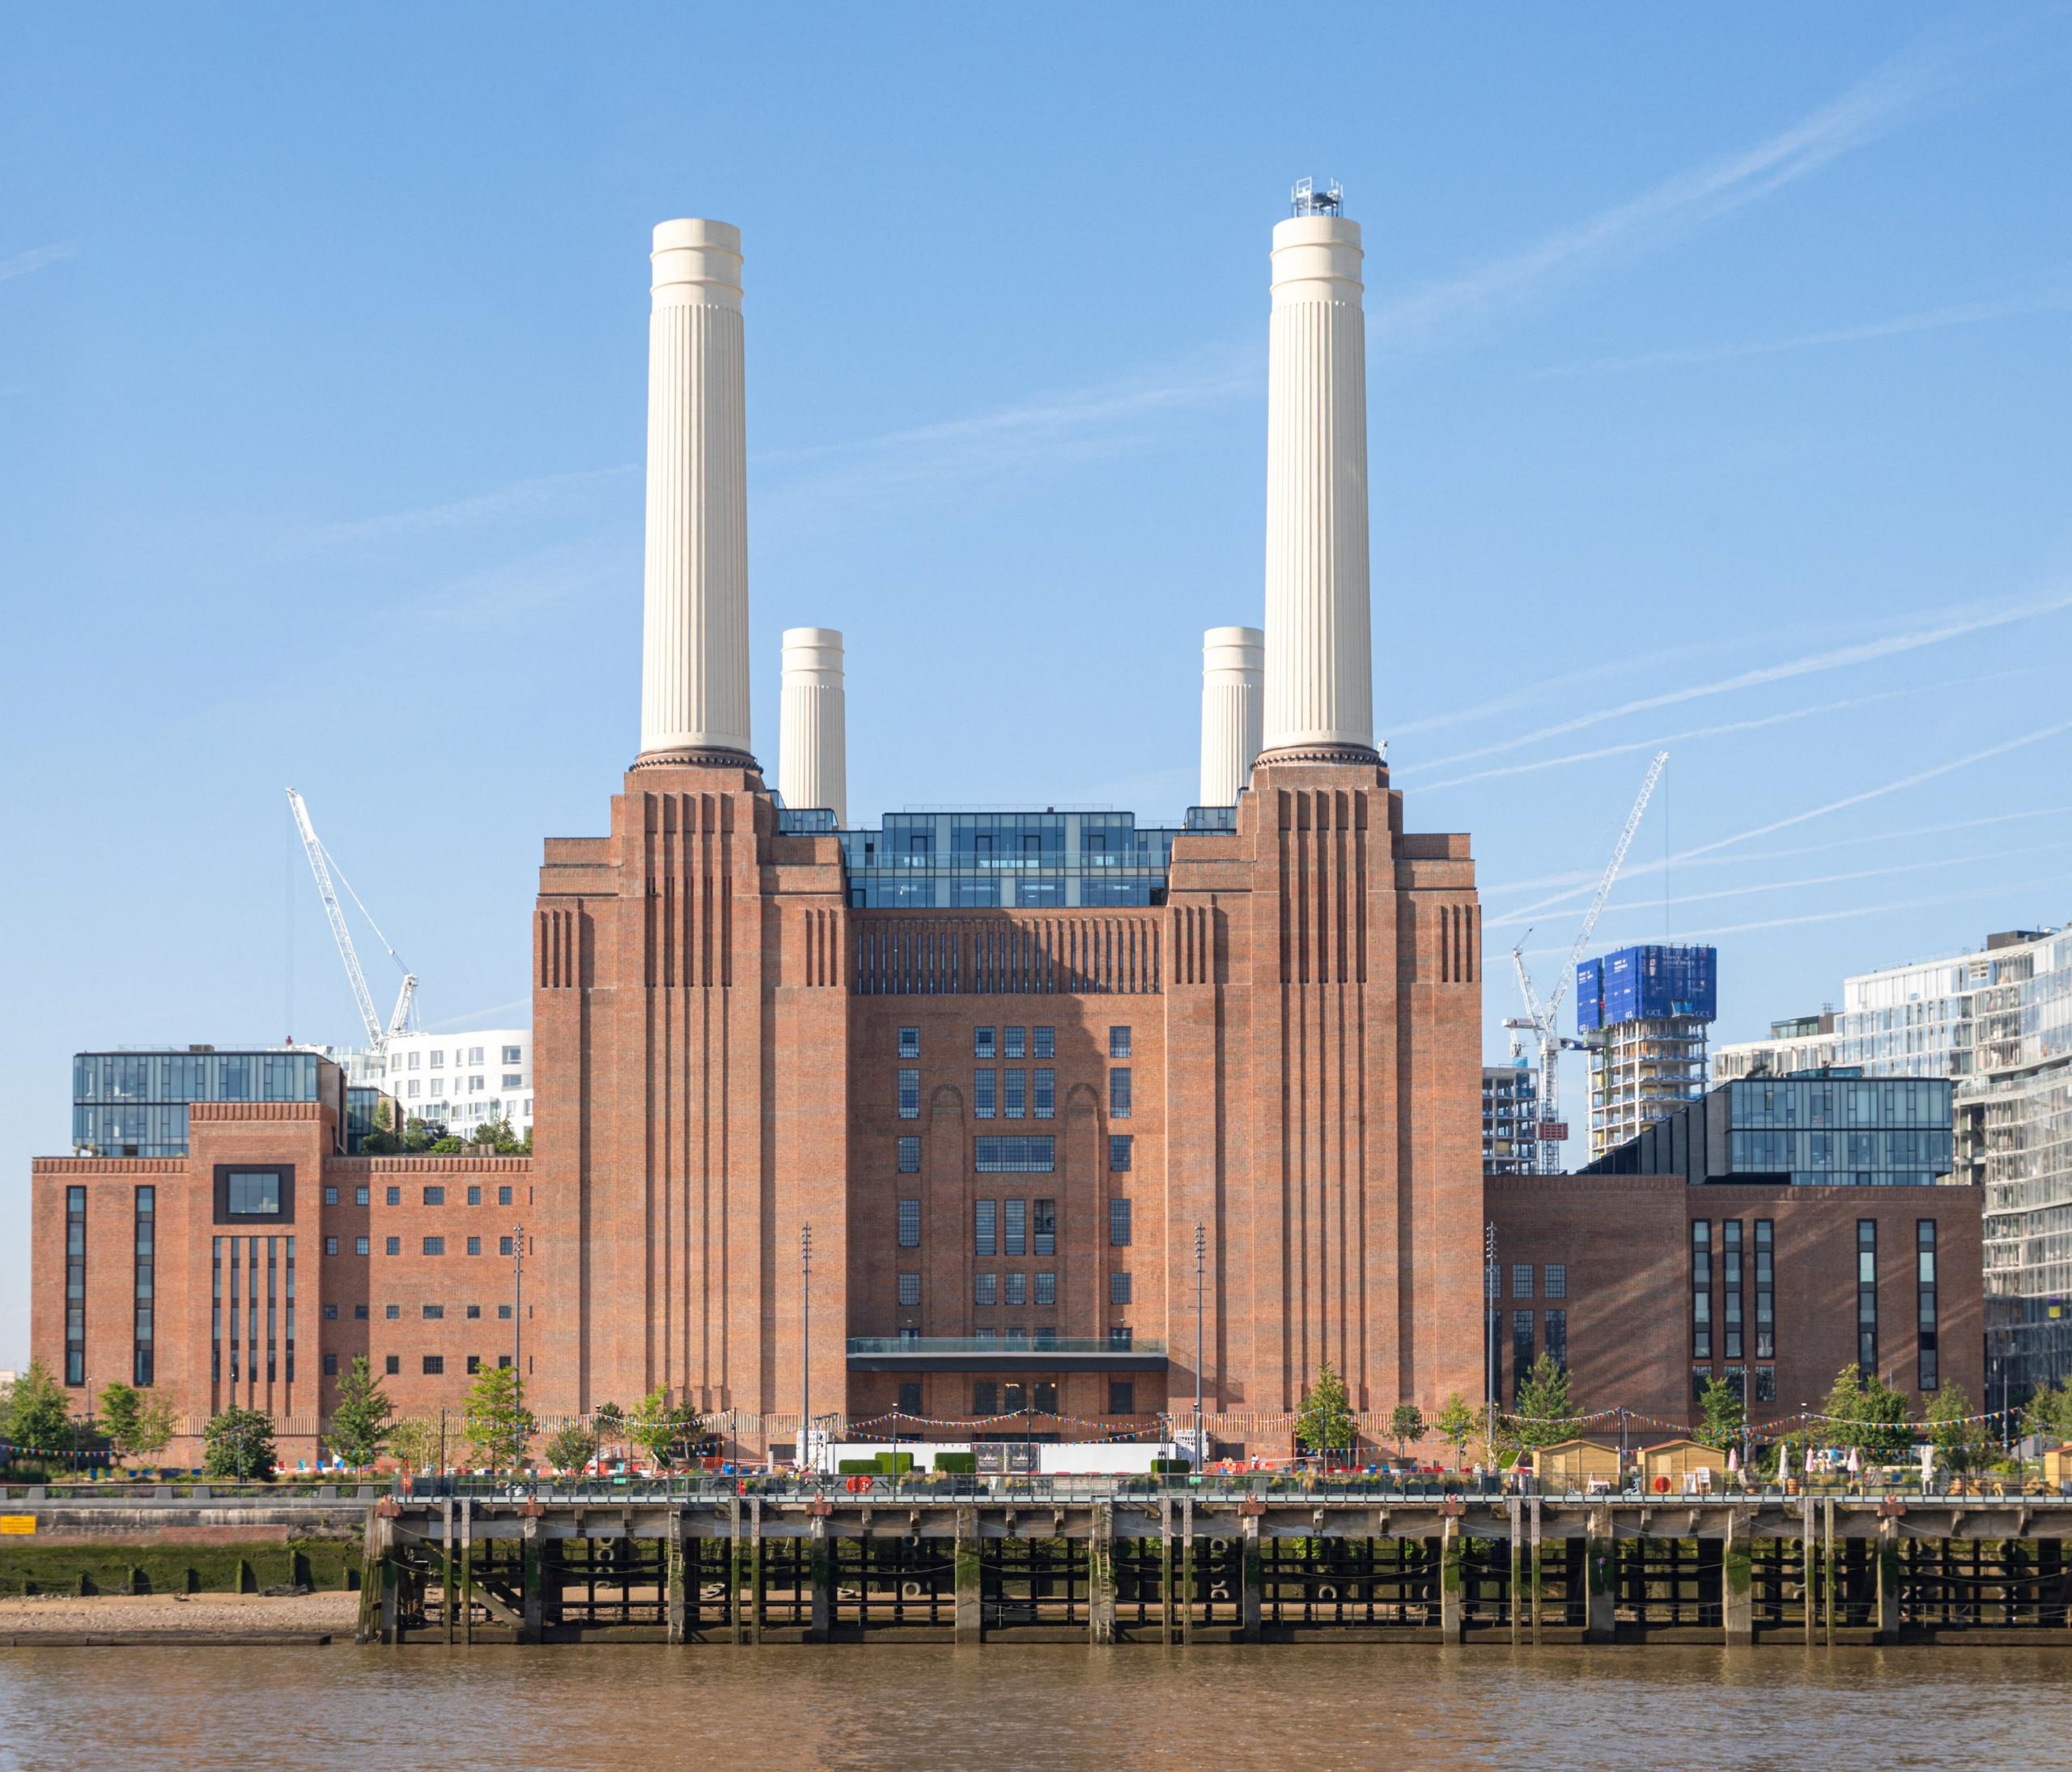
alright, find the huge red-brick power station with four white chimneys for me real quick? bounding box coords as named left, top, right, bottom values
left=33, top=199, right=1979, bottom=1461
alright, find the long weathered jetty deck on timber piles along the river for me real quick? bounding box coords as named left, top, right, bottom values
left=16, top=1477, right=2072, bottom=1647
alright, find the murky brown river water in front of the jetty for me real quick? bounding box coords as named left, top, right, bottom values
left=0, top=1643, right=2047, bottom=1772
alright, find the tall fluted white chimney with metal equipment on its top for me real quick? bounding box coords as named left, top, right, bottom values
left=1264, top=181, right=1376, bottom=763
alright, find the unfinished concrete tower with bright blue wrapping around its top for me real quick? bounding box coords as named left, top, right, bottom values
left=1575, top=945, right=1717, bottom=1158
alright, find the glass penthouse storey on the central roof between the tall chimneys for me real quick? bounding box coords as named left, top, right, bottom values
left=777, top=806, right=1237, bottom=910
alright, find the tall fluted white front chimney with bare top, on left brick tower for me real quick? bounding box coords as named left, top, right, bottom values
left=640, top=222, right=754, bottom=767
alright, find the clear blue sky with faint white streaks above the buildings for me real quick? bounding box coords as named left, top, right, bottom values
left=0, top=6, right=2072, bottom=1364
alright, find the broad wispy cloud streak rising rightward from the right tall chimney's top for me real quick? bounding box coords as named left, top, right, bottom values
left=1369, top=41, right=1943, bottom=338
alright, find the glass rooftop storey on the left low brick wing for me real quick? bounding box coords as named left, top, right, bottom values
left=73, top=1047, right=348, bottom=1157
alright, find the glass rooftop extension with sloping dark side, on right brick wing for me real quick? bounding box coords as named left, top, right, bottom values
left=1583, top=1072, right=1954, bottom=1188
